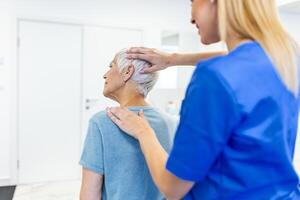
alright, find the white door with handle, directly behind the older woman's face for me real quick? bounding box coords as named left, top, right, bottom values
left=82, top=26, right=142, bottom=142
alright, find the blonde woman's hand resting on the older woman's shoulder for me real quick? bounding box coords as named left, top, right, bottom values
left=106, top=107, right=153, bottom=139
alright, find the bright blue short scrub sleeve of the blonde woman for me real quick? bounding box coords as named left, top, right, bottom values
left=166, top=69, right=238, bottom=182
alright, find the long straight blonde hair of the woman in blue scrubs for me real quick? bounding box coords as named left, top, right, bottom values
left=217, top=0, right=298, bottom=95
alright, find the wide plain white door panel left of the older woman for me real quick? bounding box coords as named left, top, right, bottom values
left=18, top=21, right=82, bottom=183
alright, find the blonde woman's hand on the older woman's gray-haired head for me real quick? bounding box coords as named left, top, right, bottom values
left=127, top=47, right=173, bottom=73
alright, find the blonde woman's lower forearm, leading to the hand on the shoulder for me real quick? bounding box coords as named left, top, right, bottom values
left=138, top=130, right=192, bottom=199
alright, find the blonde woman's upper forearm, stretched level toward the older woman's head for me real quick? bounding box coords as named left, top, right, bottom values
left=172, top=51, right=226, bottom=66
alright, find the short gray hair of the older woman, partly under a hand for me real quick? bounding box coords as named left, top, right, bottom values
left=115, top=49, right=158, bottom=97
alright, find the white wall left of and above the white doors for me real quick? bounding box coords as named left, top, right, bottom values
left=0, top=0, right=197, bottom=185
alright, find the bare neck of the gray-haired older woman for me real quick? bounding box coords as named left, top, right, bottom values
left=116, top=84, right=149, bottom=107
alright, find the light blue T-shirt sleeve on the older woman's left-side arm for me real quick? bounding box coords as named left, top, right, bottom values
left=79, top=120, right=104, bottom=175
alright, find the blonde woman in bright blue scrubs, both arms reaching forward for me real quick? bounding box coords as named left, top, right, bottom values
left=107, top=0, right=300, bottom=200
